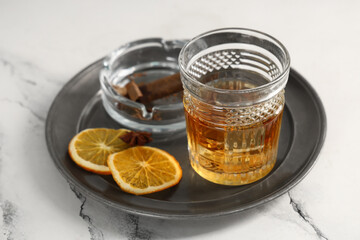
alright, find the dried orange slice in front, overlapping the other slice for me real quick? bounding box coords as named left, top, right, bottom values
left=108, top=146, right=182, bottom=195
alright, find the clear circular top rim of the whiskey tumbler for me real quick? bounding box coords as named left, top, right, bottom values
left=178, top=27, right=290, bottom=94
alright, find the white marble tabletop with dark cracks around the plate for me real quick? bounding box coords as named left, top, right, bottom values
left=0, top=0, right=360, bottom=240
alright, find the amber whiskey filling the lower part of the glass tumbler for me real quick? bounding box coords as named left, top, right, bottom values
left=184, top=80, right=284, bottom=185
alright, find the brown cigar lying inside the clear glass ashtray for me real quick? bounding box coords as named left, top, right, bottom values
left=113, top=73, right=183, bottom=104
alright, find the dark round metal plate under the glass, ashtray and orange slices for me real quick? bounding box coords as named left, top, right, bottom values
left=46, top=60, right=326, bottom=219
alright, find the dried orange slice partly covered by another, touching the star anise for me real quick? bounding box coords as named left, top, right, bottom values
left=69, top=128, right=129, bottom=175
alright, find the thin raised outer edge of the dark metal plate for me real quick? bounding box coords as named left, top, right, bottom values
left=45, top=58, right=327, bottom=220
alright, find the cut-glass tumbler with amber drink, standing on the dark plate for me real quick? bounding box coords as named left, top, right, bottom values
left=179, top=28, right=290, bottom=185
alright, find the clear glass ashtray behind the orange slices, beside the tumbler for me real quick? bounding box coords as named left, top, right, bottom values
left=100, top=38, right=187, bottom=134
